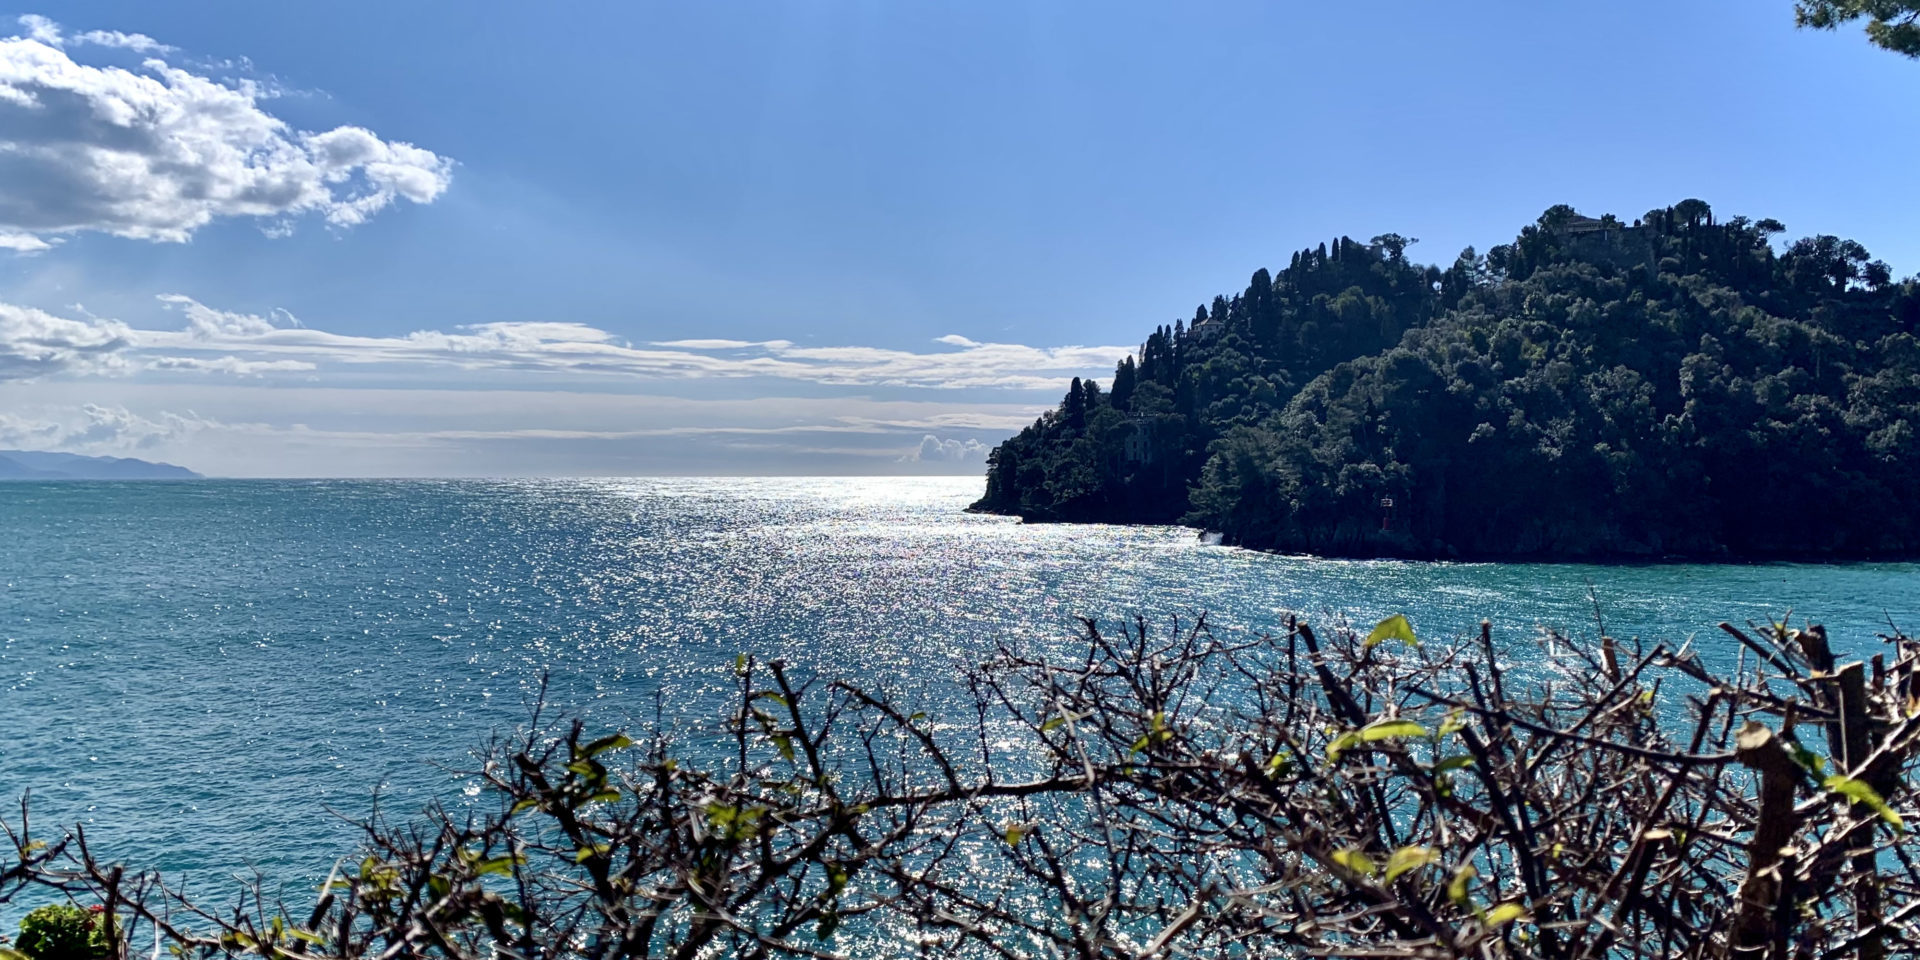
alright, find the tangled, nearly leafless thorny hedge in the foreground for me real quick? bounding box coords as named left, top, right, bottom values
left=0, top=618, right=1920, bottom=960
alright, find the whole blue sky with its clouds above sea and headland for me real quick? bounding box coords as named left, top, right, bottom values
left=0, top=0, right=1920, bottom=476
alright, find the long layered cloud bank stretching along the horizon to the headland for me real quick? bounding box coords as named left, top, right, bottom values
left=0, top=294, right=1129, bottom=476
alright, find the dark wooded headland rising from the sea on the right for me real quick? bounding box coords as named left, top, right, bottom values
left=977, top=200, right=1920, bottom=557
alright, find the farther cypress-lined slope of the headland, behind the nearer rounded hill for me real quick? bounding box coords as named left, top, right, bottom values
left=977, top=236, right=1438, bottom=522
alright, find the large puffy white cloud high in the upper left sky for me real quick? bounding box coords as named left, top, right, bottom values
left=0, top=17, right=453, bottom=252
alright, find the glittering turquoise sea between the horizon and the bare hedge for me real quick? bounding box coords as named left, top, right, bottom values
left=0, top=478, right=1920, bottom=890
